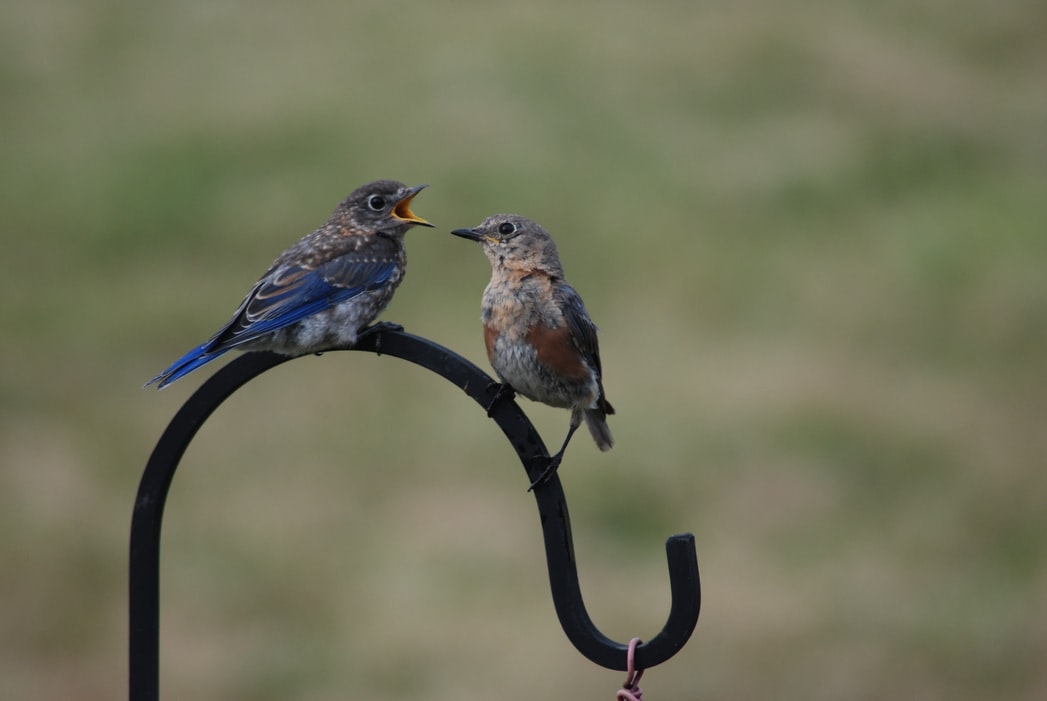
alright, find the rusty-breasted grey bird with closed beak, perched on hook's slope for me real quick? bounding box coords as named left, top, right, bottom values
left=451, top=214, right=615, bottom=487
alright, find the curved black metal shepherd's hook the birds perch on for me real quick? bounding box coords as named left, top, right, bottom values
left=129, top=324, right=701, bottom=701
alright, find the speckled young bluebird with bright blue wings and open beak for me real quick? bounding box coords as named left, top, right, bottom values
left=146, top=180, right=432, bottom=389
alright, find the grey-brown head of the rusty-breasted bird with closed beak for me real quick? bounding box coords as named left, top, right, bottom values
left=451, top=214, right=563, bottom=277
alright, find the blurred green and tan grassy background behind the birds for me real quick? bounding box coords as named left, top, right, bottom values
left=0, top=0, right=1047, bottom=701
